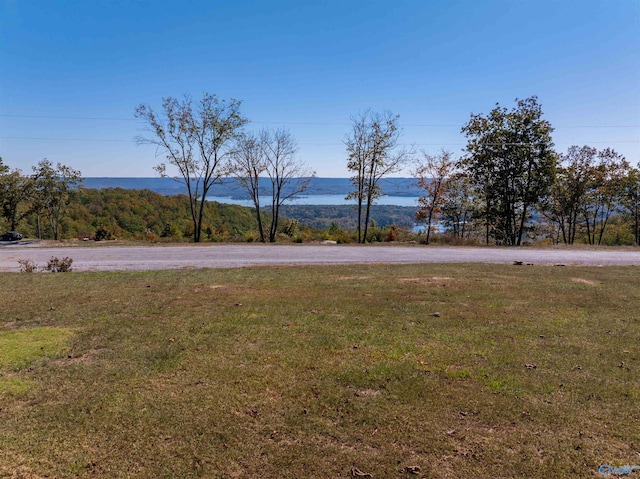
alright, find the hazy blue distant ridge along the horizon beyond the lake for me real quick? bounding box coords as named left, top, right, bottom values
left=83, top=177, right=422, bottom=198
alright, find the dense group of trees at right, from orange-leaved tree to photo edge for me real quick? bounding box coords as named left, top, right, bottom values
left=414, top=97, right=640, bottom=246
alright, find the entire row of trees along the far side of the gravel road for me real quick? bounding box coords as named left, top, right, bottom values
left=0, top=93, right=640, bottom=246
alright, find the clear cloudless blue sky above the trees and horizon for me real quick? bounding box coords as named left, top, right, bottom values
left=0, top=0, right=640, bottom=177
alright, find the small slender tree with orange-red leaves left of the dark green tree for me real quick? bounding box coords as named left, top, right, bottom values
left=413, top=149, right=455, bottom=244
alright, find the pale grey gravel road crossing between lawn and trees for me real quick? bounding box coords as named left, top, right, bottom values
left=0, top=242, right=640, bottom=271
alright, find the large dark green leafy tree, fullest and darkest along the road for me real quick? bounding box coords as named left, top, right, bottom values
left=460, top=96, right=557, bottom=246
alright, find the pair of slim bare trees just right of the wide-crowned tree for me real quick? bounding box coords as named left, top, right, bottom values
left=234, top=129, right=315, bottom=243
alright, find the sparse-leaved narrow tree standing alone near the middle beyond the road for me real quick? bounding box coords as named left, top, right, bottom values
left=344, top=110, right=412, bottom=243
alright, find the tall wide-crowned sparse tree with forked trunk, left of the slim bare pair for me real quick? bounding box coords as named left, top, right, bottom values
left=135, top=93, right=248, bottom=242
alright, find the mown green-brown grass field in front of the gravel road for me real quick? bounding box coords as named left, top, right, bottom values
left=0, top=265, right=640, bottom=479
